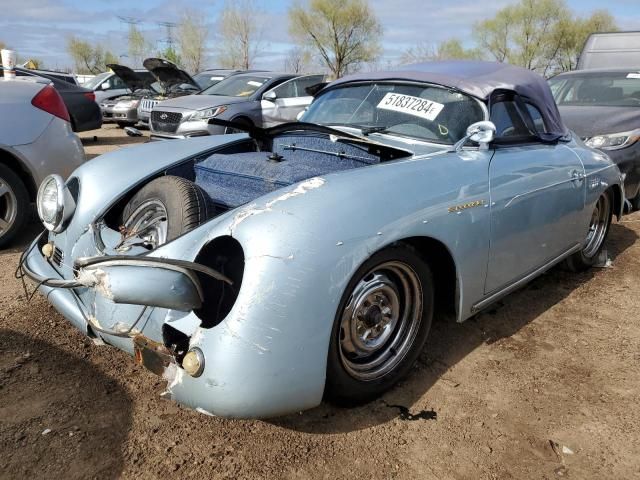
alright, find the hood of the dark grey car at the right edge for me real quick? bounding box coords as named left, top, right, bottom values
left=559, top=106, right=640, bottom=138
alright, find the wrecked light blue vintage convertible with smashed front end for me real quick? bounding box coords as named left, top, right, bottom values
left=21, top=62, right=624, bottom=417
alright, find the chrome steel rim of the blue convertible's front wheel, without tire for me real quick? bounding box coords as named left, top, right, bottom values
left=338, top=261, right=422, bottom=381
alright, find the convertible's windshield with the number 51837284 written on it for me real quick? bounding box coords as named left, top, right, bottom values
left=301, top=82, right=485, bottom=144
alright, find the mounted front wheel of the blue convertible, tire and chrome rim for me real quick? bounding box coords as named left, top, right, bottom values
left=325, top=246, right=433, bottom=404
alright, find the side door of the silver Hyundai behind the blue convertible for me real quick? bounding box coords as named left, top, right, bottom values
left=260, top=75, right=324, bottom=127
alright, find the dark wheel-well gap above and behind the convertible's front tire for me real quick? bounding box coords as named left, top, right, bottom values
left=397, top=237, right=458, bottom=314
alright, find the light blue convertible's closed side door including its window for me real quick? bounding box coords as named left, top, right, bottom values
left=485, top=96, right=585, bottom=294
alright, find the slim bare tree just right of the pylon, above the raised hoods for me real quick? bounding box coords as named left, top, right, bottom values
left=176, top=10, right=209, bottom=73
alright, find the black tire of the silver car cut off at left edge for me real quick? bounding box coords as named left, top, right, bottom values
left=0, top=164, right=31, bottom=248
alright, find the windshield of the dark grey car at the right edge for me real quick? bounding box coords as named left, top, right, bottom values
left=549, top=72, right=640, bottom=107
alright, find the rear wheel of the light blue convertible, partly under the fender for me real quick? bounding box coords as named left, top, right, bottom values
left=567, top=192, right=613, bottom=272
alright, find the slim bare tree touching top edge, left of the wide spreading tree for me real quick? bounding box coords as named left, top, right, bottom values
left=216, top=0, right=263, bottom=70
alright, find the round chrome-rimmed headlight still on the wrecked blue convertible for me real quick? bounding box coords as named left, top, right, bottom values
left=36, top=175, right=76, bottom=232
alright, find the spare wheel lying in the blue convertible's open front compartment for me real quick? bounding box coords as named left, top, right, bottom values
left=122, top=175, right=214, bottom=249
